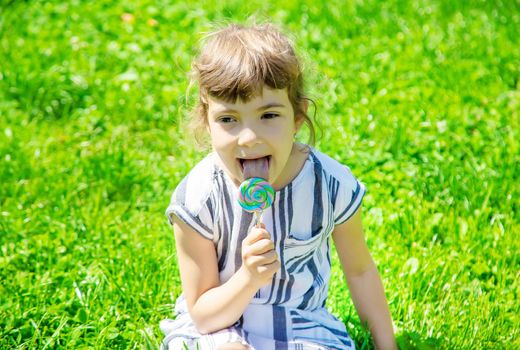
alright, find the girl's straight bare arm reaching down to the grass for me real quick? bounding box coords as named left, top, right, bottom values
left=332, top=208, right=397, bottom=349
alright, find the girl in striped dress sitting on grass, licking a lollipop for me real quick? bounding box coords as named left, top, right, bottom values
left=161, top=25, right=396, bottom=350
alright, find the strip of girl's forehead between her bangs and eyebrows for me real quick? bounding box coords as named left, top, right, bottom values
left=208, top=87, right=291, bottom=113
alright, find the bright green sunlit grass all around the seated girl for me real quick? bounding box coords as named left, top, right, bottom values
left=0, top=0, right=520, bottom=349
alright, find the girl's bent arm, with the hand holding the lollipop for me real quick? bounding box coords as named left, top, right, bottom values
left=174, top=218, right=279, bottom=334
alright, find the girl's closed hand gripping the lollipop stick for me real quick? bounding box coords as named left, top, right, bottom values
left=240, top=224, right=281, bottom=288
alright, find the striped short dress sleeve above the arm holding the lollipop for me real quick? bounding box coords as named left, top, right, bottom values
left=165, top=177, right=214, bottom=239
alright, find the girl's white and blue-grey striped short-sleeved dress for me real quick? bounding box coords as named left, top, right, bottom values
left=160, top=149, right=365, bottom=350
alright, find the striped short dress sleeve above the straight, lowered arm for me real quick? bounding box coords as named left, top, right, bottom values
left=332, top=166, right=366, bottom=225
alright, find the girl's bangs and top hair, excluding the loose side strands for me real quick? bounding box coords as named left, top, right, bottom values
left=194, top=23, right=300, bottom=103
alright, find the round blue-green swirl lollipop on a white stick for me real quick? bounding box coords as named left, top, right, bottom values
left=238, top=177, right=275, bottom=223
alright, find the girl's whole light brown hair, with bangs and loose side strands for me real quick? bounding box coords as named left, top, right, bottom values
left=190, top=24, right=315, bottom=145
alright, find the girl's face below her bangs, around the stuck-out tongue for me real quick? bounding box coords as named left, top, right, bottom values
left=207, top=86, right=302, bottom=188
